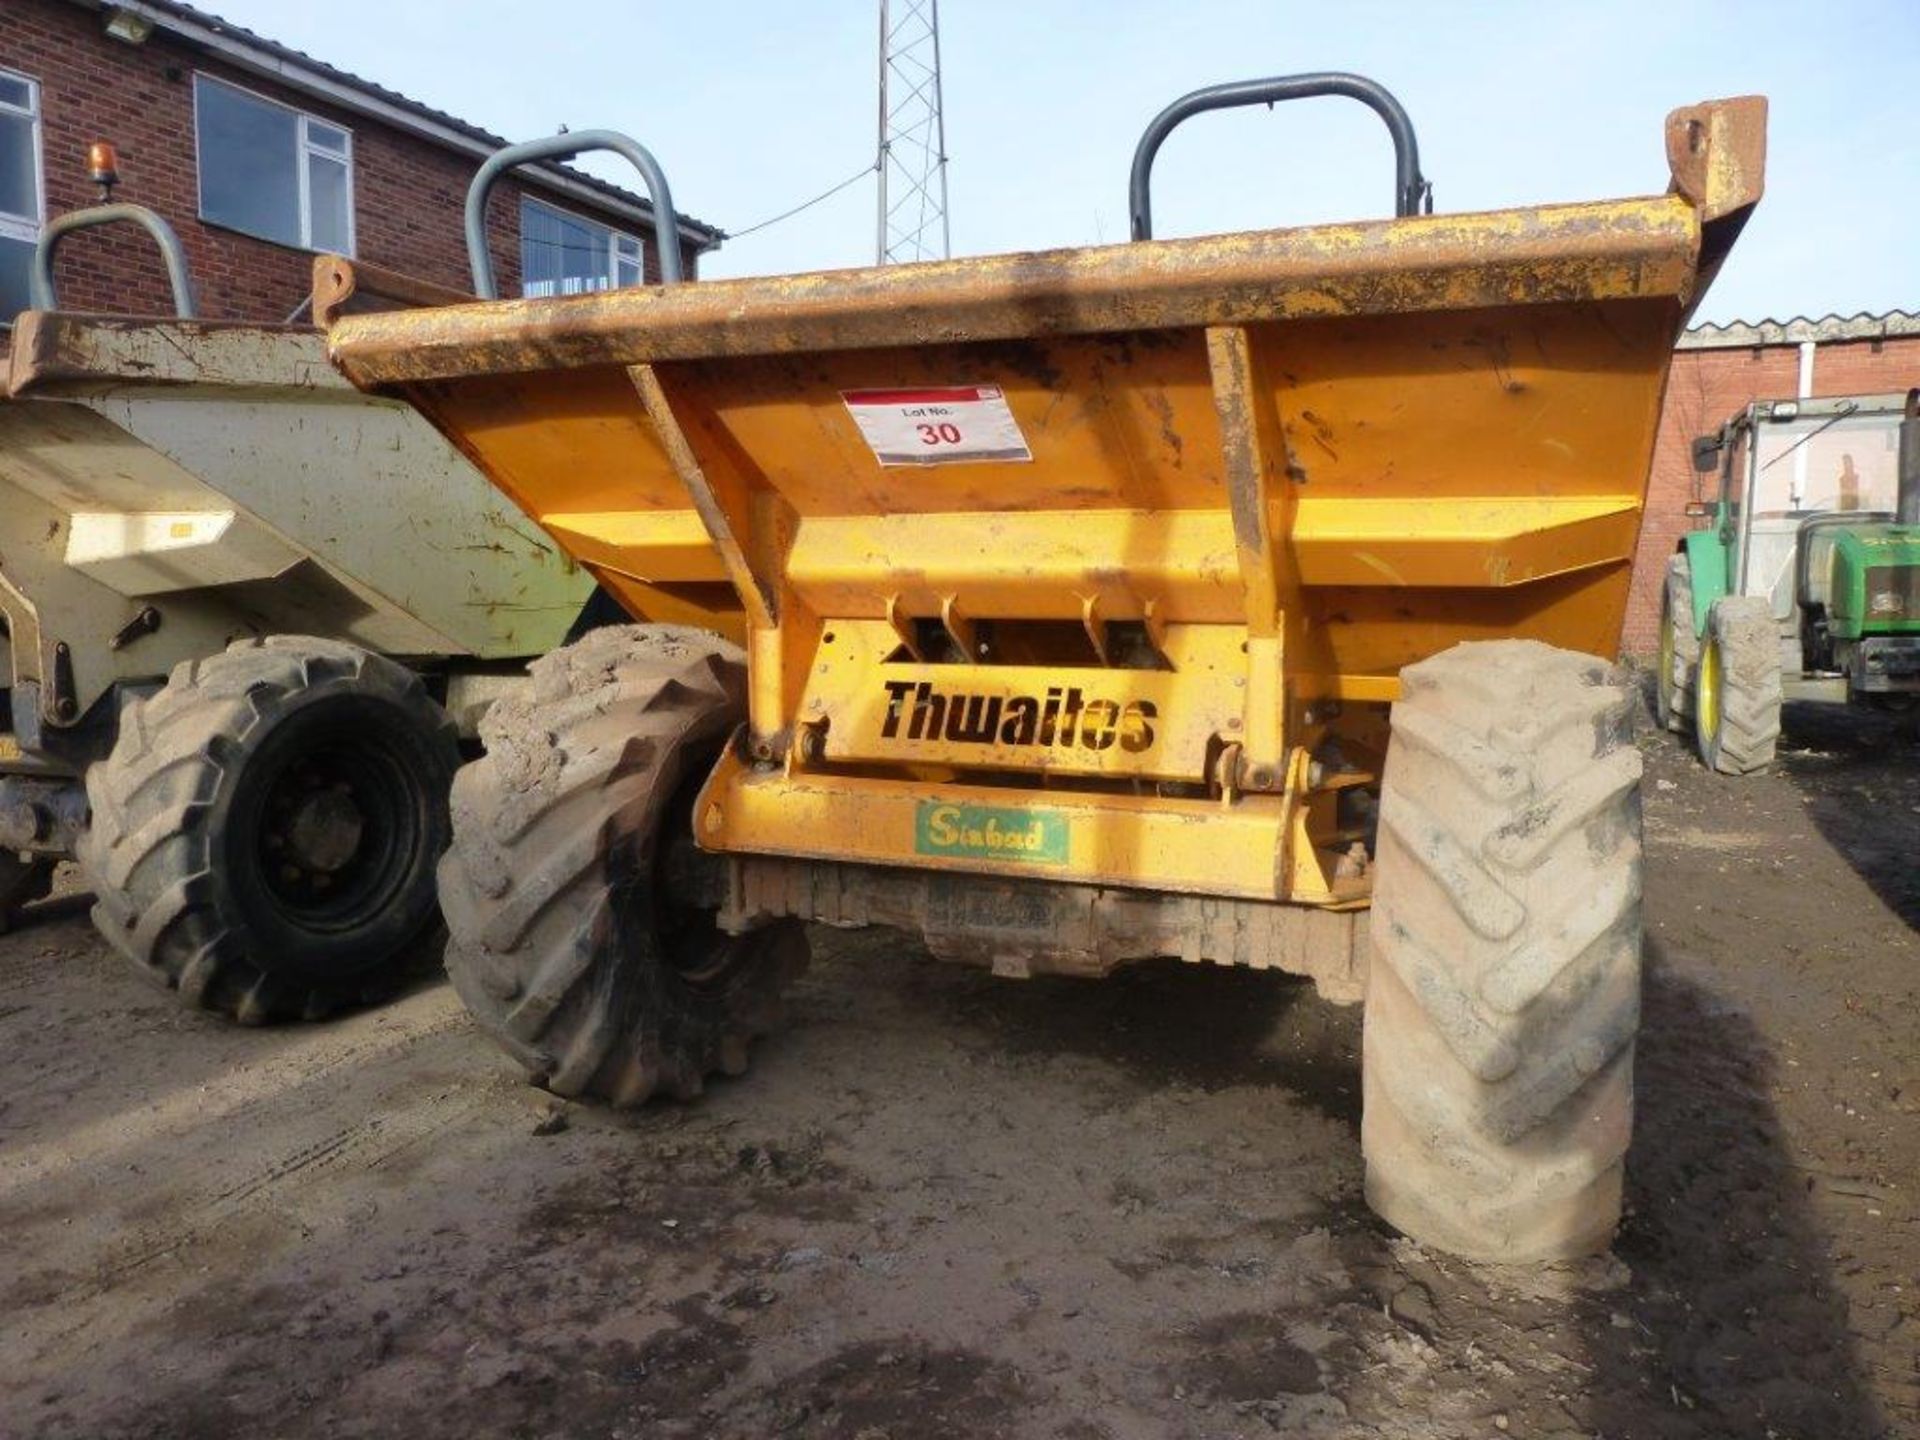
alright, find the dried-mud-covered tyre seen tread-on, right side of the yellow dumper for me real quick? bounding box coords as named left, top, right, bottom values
left=1361, top=639, right=1640, bottom=1263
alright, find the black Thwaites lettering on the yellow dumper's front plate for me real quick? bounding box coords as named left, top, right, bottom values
left=879, top=680, right=1160, bottom=755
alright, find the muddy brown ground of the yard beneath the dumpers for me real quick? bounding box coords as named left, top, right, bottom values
left=0, top=712, right=1920, bottom=1440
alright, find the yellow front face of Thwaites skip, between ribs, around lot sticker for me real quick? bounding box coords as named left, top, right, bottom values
left=370, top=298, right=1678, bottom=674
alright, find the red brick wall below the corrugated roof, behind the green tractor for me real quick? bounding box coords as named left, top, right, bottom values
left=1620, top=336, right=1920, bottom=657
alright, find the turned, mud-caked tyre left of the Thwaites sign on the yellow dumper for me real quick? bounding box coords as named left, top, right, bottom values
left=440, top=626, right=806, bottom=1106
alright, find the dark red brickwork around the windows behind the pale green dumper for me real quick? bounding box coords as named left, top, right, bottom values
left=0, top=0, right=693, bottom=326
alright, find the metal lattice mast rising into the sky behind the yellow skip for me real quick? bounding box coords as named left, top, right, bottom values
left=876, top=0, right=952, bottom=265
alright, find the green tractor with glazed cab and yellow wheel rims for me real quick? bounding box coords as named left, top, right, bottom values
left=1657, top=390, right=1920, bottom=776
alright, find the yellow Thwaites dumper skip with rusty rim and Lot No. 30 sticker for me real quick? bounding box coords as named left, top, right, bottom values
left=332, top=98, right=1764, bottom=902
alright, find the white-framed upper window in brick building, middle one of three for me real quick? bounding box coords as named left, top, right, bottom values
left=194, top=75, right=353, bottom=255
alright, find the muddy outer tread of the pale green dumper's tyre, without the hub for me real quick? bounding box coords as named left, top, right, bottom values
left=75, top=636, right=459, bottom=1025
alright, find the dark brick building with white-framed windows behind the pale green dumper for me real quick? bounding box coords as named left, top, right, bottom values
left=0, top=0, right=724, bottom=332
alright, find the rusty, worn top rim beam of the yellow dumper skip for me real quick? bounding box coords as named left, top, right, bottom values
left=330, top=196, right=1699, bottom=386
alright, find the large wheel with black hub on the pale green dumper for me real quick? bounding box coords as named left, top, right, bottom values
left=79, top=636, right=459, bottom=1025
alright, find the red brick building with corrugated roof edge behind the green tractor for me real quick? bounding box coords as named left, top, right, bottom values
left=1620, top=311, right=1920, bottom=657
